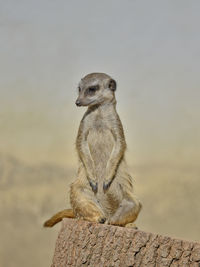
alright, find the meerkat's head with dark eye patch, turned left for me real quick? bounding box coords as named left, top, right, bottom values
left=76, top=73, right=117, bottom=106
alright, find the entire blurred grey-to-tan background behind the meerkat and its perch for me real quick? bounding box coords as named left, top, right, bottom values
left=0, top=0, right=200, bottom=267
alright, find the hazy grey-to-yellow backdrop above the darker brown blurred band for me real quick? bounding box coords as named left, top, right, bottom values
left=0, top=0, right=200, bottom=166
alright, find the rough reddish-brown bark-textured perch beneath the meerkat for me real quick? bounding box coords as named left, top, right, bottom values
left=52, top=219, right=200, bottom=267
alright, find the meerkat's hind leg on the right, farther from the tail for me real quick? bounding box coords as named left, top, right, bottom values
left=109, top=199, right=142, bottom=226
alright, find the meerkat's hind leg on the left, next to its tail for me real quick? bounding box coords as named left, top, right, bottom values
left=70, top=182, right=106, bottom=223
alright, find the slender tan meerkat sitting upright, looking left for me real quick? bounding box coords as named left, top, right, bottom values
left=44, top=73, right=142, bottom=227
